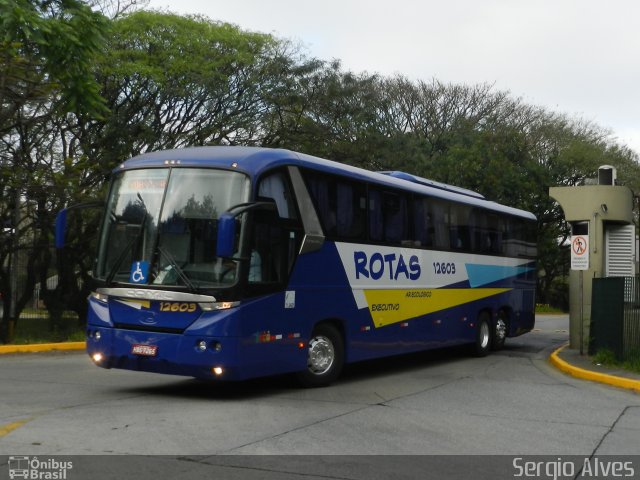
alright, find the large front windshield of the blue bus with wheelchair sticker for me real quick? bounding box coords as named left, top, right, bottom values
left=96, top=168, right=250, bottom=289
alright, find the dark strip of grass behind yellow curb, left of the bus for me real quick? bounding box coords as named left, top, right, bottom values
left=11, top=315, right=85, bottom=345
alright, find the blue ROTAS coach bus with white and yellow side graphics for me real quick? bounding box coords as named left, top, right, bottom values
left=58, top=147, right=536, bottom=386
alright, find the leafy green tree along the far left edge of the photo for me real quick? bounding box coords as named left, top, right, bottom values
left=0, top=0, right=106, bottom=341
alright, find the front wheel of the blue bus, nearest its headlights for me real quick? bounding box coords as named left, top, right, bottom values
left=297, top=323, right=344, bottom=387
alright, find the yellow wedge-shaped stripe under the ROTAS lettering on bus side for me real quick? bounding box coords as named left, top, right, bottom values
left=364, top=288, right=511, bottom=327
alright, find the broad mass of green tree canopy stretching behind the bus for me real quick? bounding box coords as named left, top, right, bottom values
left=0, top=5, right=640, bottom=339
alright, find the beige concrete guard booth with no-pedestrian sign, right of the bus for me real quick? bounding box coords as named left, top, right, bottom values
left=549, top=165, right=636, bottom=353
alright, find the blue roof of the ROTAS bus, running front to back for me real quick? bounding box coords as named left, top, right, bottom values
left=120, top=146, right=536, bottom=220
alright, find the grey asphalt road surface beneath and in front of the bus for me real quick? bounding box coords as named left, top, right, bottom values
left=0, top=316, right=640, bottom=479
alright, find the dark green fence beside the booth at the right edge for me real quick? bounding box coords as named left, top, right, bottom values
left=589, top=276, right=640, bottom=360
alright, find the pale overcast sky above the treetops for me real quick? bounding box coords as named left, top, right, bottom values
left=148, top=0, right=640, bottom=155
